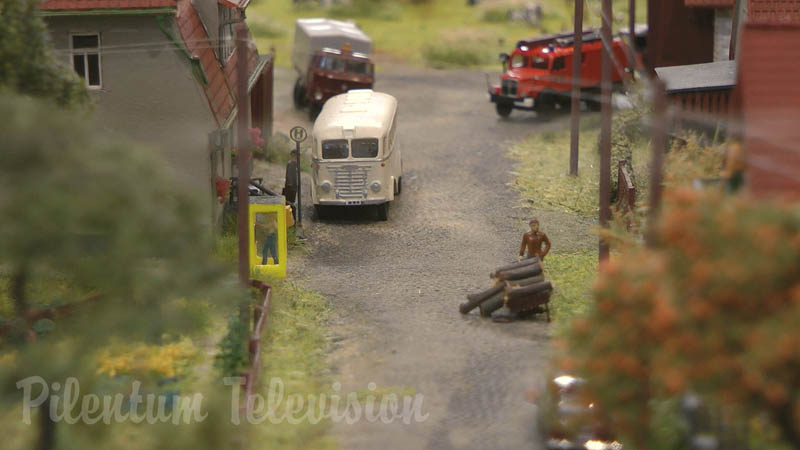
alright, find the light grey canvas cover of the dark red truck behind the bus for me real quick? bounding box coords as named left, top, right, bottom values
left=292, top=19, right=372, bottom=76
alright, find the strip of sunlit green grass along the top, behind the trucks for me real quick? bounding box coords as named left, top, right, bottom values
left=247, top=0, right=647, bottom=68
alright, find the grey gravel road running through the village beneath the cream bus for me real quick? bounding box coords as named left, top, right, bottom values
left=260, top=68, right=565, bottom=449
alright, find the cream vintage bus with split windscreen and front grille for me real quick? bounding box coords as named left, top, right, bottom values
left=311, top=89, right=403, bottom=220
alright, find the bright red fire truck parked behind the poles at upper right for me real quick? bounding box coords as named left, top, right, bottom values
left=489, top=31, right=633, bottom=117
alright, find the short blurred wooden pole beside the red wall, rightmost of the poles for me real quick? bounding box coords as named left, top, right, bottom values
left=645, top=78, right=667, bottom=246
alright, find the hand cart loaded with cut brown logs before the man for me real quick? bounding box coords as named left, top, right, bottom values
left=458, top=256, right=553, bottom=322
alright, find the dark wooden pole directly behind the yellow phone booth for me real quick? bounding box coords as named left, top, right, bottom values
left=236, top=22, right=250, bottom=286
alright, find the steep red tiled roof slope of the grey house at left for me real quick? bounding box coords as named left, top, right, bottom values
left=175, top=0, right=258, bottom=126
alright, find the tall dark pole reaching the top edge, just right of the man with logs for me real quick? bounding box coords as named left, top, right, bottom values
left=599, top=0, right=613, bottom=262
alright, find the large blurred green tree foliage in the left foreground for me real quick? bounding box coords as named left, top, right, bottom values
left=0, top=96, right=246, bottom=448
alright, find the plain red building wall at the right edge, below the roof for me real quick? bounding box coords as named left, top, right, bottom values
left=739, top=23, right=800, bottom=198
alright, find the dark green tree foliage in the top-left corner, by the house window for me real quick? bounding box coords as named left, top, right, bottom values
left=0, top=0, right=89, bottom=106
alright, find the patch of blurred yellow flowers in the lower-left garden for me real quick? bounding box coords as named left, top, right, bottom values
left=97, top=338, right=198, bottom=378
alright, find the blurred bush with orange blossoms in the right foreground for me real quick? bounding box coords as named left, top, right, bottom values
left=564, top=190, right=800, bottom=448
